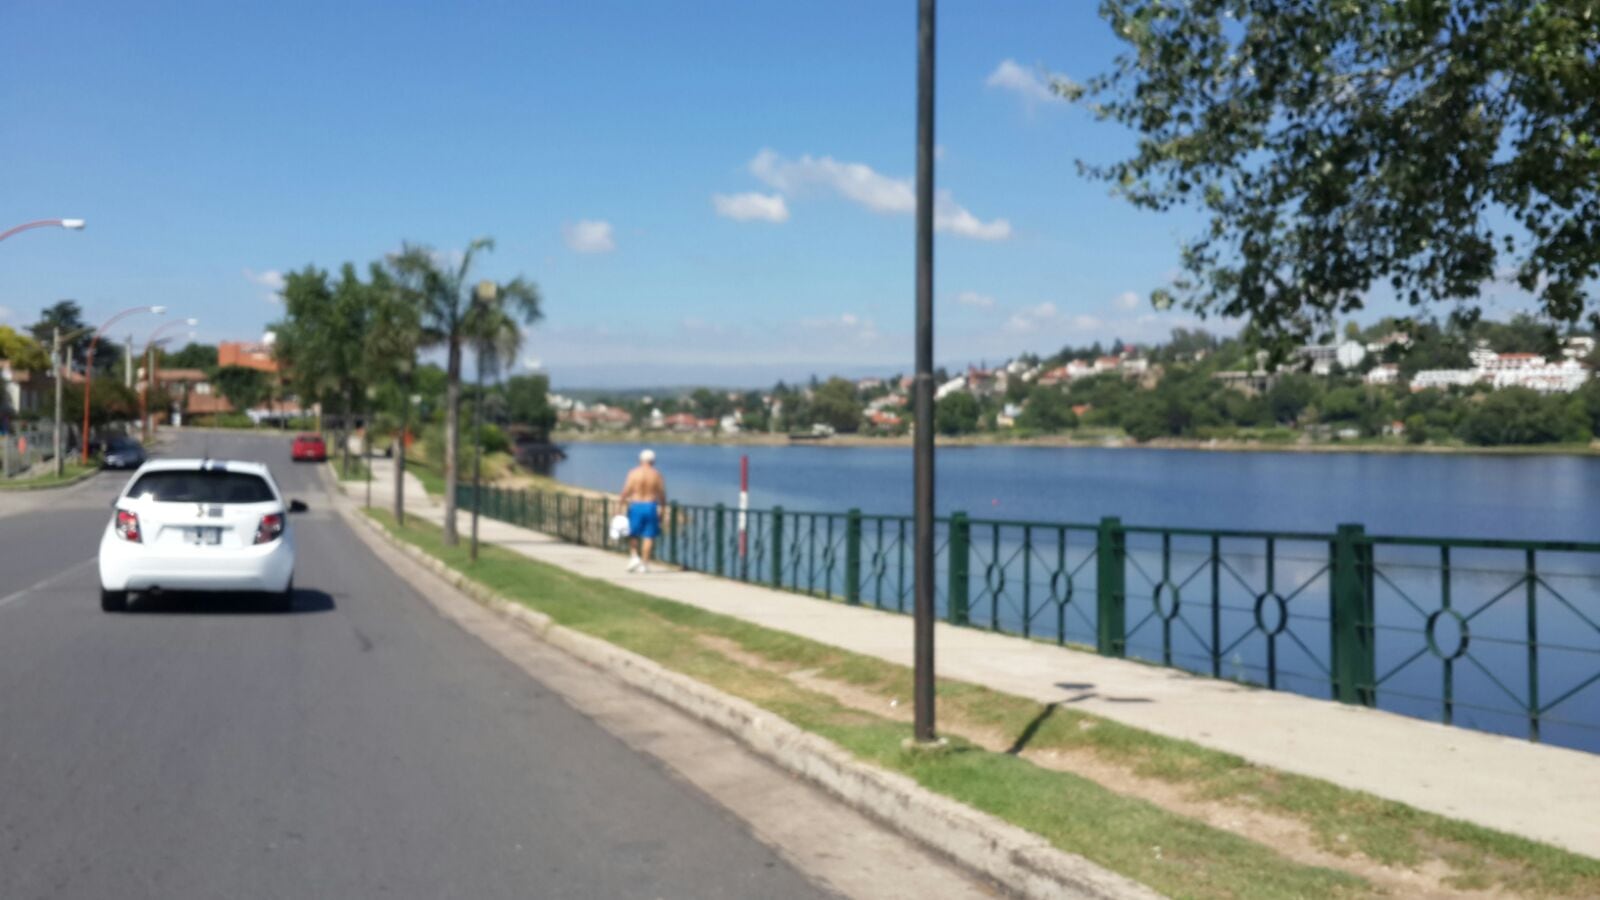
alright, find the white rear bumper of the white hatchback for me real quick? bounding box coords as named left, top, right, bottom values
left=99, top=532, right=294, bottom=593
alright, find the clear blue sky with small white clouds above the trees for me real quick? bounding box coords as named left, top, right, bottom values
left=0, top=0, right=1523, bottom=386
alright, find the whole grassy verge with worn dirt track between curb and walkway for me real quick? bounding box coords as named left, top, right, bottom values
left=370, top=511, right=1600, bottom=897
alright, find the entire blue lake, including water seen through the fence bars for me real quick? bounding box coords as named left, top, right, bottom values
left=555, top=444, right=1600, bottom=751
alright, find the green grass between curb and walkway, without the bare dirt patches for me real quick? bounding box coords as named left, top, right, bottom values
left=371, top=511, right=1600, bottom=897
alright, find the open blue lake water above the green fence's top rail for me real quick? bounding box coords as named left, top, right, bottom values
left=555, top=444, right=1600, bottom=541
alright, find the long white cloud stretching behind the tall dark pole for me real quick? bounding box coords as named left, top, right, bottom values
left=750, top=149, right=1011, bottom=240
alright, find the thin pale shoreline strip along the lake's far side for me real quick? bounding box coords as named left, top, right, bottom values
left=550, top=429, right=1600, bottom=456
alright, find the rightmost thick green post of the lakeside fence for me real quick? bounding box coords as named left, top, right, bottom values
left=1330, top=525, right=1378, bottom=706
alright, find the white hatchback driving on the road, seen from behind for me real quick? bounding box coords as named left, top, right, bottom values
left=99, top=460, right=306, bottom=612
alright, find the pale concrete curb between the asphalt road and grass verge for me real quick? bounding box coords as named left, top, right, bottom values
left=341, top=504, right=1160, bottom=898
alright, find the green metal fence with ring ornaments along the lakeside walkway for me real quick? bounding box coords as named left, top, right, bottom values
left=459, top=485, right=1600, bottom=749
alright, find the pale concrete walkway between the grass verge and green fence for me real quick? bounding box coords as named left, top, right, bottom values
left=346, top=469, right=1600, bottom=858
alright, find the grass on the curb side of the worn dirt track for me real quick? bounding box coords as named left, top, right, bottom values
left=370, top=509, right=1395, bottom=897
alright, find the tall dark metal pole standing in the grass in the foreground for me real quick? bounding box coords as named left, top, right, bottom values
left=912, top=0, right=938, bottom=743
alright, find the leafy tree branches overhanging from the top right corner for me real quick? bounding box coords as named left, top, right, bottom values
left=1058, top=0, right=1600, bottom=343
